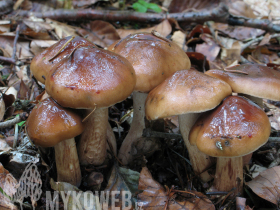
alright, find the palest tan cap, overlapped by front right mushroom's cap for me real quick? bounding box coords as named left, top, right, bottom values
left=146, top=69, right=231, bottom=120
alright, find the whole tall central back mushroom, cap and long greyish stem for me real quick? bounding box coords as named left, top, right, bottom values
left=108, top=31, right=190, bottom=165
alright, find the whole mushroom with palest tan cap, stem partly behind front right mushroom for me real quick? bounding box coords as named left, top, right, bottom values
left=146, top=69, right=231, bottom=182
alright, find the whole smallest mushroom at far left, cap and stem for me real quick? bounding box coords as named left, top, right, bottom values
left=26, top=98, right=84, bottom=186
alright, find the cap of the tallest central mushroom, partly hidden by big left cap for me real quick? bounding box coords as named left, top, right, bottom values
left=108, top=33, right=191, bottom=92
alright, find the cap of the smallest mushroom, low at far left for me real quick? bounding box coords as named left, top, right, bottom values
left=26, top=98, right=84, bottom=147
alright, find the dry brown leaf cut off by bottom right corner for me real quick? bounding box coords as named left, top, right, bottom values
left=246, top=166, right=280, bottom=205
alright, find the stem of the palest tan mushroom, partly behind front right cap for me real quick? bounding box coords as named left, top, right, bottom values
left=179, top=113, right=214, bottom=182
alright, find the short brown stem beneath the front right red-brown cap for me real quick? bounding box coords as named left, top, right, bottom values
left=214, top=157, right=243, bottom=194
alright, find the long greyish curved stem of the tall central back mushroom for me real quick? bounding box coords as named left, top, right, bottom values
left=118, top=92, right=148, bottom=165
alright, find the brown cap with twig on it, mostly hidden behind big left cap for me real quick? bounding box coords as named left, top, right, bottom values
left=30, top=36, right=95, bottom=84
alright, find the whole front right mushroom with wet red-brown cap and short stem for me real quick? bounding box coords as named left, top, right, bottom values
left=190, top=96, right=270, bottom=192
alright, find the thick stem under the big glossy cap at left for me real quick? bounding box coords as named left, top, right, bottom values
left=78, top=108, right=108, bottom=165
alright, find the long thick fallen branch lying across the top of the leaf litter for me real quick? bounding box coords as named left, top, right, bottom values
left=13, top=3, right=280, bottom=32
